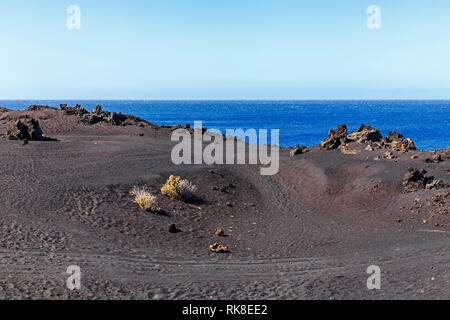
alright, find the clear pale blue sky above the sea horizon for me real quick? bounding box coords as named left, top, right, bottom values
left=0, top=0, right=450, bottom=99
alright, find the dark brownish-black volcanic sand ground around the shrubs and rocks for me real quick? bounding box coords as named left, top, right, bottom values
left=0, top=109, right=450, bottom=299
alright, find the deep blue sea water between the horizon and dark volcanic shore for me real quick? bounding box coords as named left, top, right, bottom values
left=0, top=100, right=450, bottom=150
